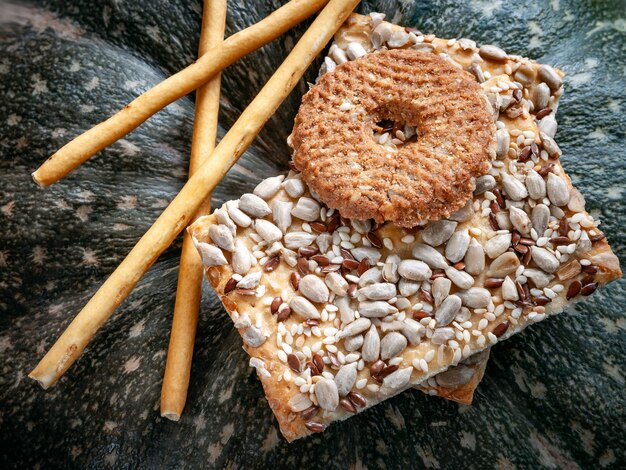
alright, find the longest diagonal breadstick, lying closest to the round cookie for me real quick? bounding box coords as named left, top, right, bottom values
left=29, top=0, right=359, bottom=388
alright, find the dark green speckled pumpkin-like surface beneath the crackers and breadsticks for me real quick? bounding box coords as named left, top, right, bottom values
left=0, top=0, right=626, bottom=469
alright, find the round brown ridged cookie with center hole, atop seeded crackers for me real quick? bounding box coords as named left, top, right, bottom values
left=292, top=49, right=495, bottom=227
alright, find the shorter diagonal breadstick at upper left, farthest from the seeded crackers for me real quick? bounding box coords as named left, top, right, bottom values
left=32, top=0, right=328, bottom=186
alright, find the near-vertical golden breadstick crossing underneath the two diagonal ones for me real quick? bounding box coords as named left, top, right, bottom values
left=161, top=0, right=226, bottom=421
